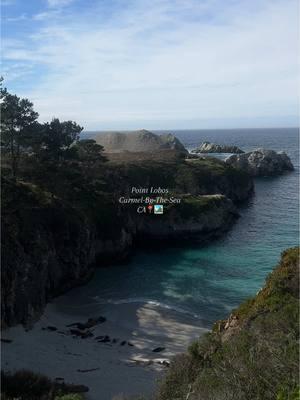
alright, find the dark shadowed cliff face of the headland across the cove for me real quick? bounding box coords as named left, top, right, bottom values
left=1, top=158, right=252, bottom=327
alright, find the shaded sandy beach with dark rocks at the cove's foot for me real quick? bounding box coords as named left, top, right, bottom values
left=2, top=289, right=206, bottom=400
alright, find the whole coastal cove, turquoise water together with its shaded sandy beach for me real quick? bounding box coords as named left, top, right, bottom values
left=3, top=129, right=299, bottom=400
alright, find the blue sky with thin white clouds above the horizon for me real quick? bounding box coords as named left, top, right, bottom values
left=2, top=0, right=299, bottom=130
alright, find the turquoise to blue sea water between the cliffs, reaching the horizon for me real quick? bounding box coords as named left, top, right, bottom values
left=81, top=129, right=299, bottom=327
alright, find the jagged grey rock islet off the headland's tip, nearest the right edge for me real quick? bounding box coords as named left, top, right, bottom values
left=225, top=149, right=294, bottom=176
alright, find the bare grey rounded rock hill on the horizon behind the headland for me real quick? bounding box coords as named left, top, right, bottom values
left=95, top=129, right=187, bottom=153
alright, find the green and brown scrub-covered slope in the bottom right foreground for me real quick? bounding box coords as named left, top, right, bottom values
left=157, top=248, right=299, bottom=400
